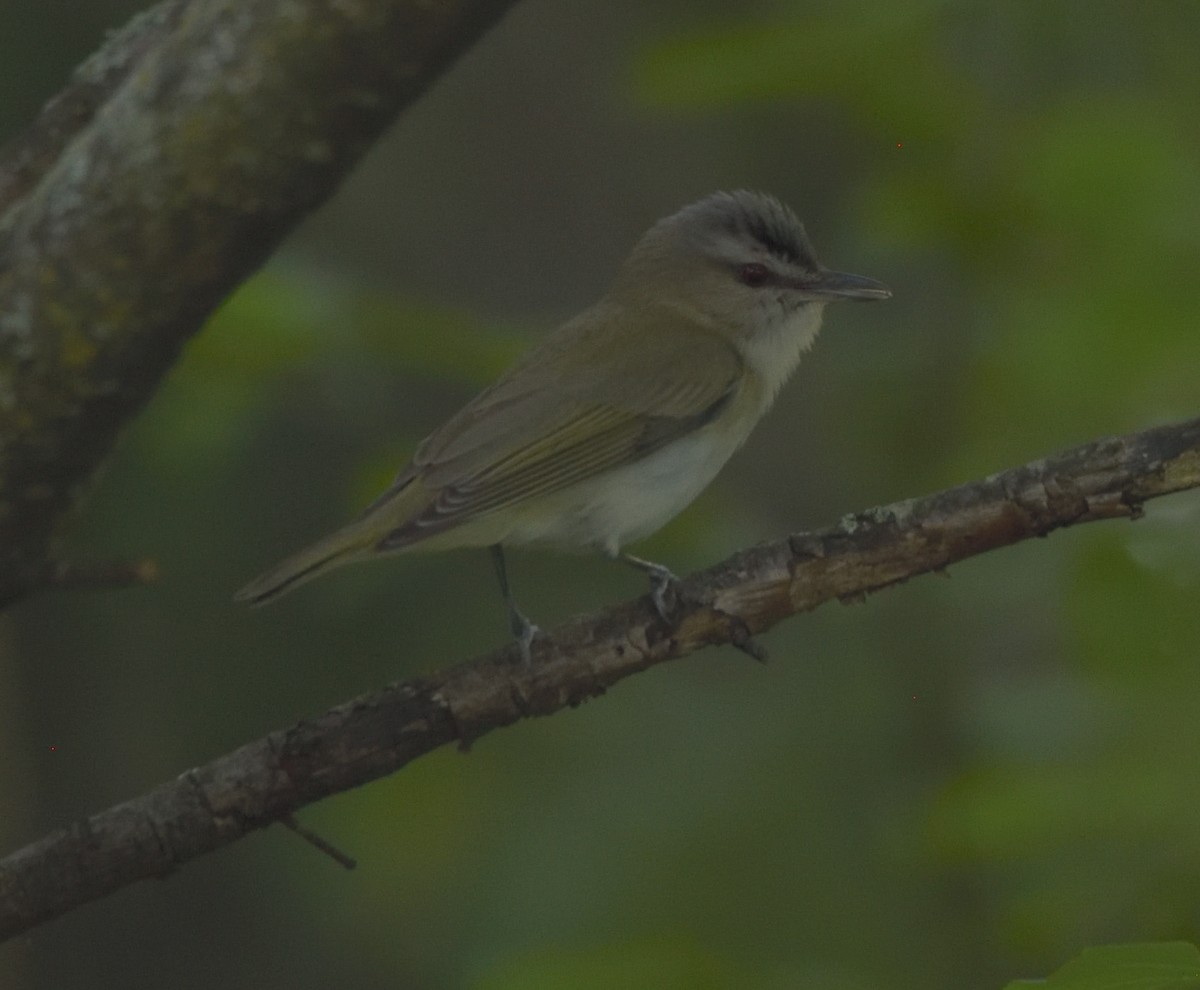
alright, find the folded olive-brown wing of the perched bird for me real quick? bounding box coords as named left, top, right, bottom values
left=377, top=304, right=743, bottom=550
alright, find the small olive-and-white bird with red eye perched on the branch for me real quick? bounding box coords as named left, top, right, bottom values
left=238, top=192, right=890, bottom=659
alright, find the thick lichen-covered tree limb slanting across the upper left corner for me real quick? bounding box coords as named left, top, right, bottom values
left=0, top=0, right=514, bottom=605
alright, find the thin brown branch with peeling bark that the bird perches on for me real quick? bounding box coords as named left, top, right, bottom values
left=0, top=419, right=1200, bottom=938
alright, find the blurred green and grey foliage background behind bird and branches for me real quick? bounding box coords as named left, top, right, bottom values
left=0, top=0, right=1200, bottom=990
